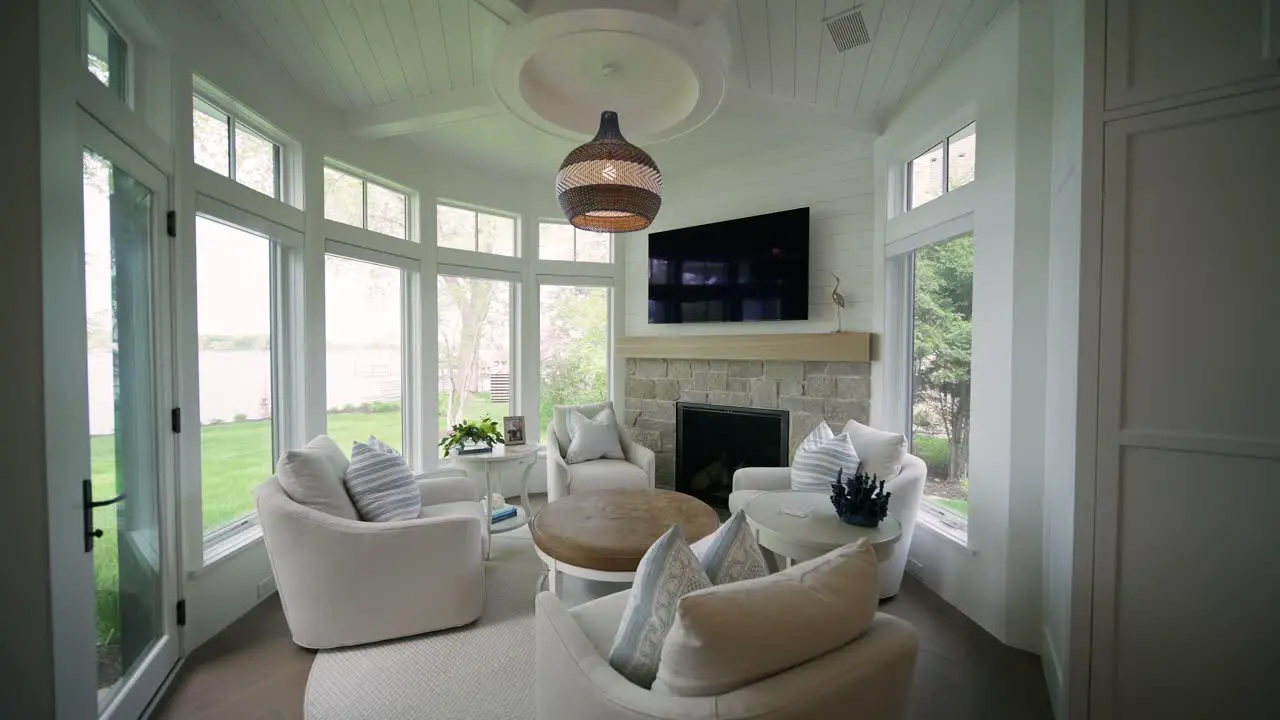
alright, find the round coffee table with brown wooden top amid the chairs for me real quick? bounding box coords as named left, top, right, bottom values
left=529, top=488, right=719, bottom=592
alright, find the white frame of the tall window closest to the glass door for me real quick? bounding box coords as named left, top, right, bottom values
left=186, top=193, right=303, bottom=558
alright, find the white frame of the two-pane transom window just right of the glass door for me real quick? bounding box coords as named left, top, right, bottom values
left=188, top=81, right=293, bottom=208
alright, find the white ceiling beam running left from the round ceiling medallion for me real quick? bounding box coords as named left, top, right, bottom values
left=346, top=85, right=506, bottom=138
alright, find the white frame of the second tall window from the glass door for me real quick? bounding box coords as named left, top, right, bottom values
left=321, top=240, right=422, bottom=461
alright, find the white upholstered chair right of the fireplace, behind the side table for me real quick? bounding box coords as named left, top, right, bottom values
left=728, top=445, right=925, bottom=598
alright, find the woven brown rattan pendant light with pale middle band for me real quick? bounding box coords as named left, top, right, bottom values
left=556, top=110, right=662, bottom=233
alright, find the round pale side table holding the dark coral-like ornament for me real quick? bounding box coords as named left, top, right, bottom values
left=742, top=491, right=902, bottom=562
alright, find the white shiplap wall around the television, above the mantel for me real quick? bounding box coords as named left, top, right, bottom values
left=621, top=141, right=874, bottom=336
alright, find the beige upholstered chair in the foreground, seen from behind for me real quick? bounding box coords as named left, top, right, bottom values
left=536, top=591, right=918, bottom=720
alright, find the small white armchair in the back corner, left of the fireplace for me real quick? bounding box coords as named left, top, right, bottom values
left=547, top=402, right=655, bottom=502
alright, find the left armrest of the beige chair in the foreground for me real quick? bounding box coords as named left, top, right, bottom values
left=535, top=592, right=717, bottom=720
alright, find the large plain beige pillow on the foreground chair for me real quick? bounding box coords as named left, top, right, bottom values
left=653, top=539, right=879, bottom=697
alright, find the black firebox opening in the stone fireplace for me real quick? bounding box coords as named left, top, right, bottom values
left=676, top=402, right=791, bottom=507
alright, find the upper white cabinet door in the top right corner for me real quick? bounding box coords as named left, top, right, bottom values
left=1106, top=0, right=1280, bottom=109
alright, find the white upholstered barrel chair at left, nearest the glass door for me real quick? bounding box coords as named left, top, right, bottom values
left=256, top=475, right=485, bottom=650
